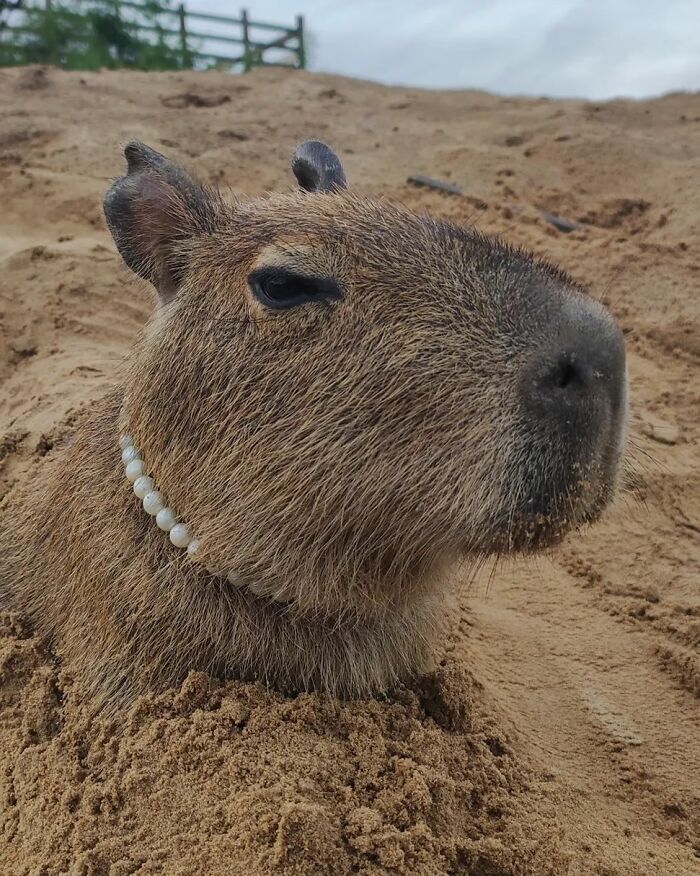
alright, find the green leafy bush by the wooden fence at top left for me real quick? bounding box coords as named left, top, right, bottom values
left=0, top=0, right=193, bottom=70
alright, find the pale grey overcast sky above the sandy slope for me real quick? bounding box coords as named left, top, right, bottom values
left=186, top=0, right=700, bottom=99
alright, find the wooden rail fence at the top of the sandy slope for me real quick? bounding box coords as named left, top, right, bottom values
left=0, top=0, right=306, bottom=72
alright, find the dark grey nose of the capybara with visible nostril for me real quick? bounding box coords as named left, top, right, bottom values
left=522, top=295, right=625, bottom=429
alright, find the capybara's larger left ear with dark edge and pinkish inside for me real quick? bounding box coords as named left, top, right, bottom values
left=104, top=140, right=216, bottom=301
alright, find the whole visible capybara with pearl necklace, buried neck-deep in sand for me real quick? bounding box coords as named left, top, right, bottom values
left=0, top=142, right=627, bottom=707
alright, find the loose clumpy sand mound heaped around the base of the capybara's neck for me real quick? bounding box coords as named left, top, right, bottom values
left=0, top=624, right=558, bottom=876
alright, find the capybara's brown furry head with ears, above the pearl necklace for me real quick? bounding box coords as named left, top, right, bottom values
left=105, top=142, right=626, bottom=616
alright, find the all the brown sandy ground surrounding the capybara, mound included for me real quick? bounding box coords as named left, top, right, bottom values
left=0, top=68, right=700, bottom=876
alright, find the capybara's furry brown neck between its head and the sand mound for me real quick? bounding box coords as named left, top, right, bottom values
left=0, top=391, right=444, bottom=708
